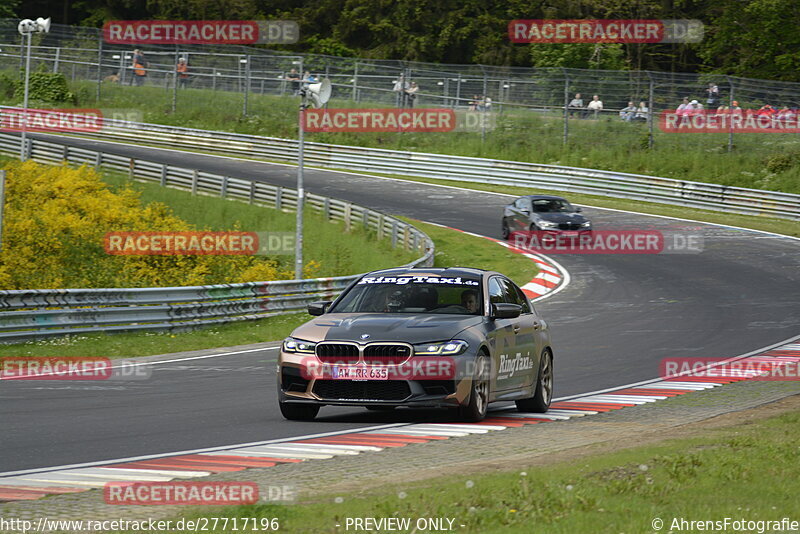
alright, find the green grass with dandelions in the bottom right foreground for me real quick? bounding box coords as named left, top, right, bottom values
left=164, top=404, right=800, bottom=534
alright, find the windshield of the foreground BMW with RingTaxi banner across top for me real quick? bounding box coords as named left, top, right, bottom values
left=330, top=274, right=483, bottom=315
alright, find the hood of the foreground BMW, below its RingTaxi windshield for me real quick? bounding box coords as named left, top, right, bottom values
left=292, top=313, right=484, bottom=344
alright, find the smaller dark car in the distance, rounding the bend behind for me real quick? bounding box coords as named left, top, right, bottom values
left=501, top=195, right=592, bottom=239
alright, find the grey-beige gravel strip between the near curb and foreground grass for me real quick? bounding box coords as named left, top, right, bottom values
left=6, top=370, right=800, bottom=520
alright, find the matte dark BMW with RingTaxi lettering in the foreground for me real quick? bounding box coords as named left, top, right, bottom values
left=278, top=268, right=553, bottom=421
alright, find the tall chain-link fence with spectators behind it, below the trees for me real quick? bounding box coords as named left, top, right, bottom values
left=0, top=19, right=800, bottom=158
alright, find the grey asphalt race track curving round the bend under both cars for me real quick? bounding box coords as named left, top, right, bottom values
left=0, top=135, right=800, bottom=472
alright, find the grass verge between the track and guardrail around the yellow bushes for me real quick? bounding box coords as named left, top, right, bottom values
left=0, top=216, right=537, bottom=358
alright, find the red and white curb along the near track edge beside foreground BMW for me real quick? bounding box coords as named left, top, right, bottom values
left=0, top=338, right=800, bottom=501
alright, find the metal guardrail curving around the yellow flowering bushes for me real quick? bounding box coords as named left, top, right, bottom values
left=0, top=133, right=434, bottom=342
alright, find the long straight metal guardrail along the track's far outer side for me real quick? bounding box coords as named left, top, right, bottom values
left=37, top=120, right=800, bottom=220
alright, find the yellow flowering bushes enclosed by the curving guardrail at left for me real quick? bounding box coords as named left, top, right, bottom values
left=0, top=161, right=304, bottom=289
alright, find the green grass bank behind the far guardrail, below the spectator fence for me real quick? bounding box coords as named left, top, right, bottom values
left=15, top=78, right=800, bottom=193
